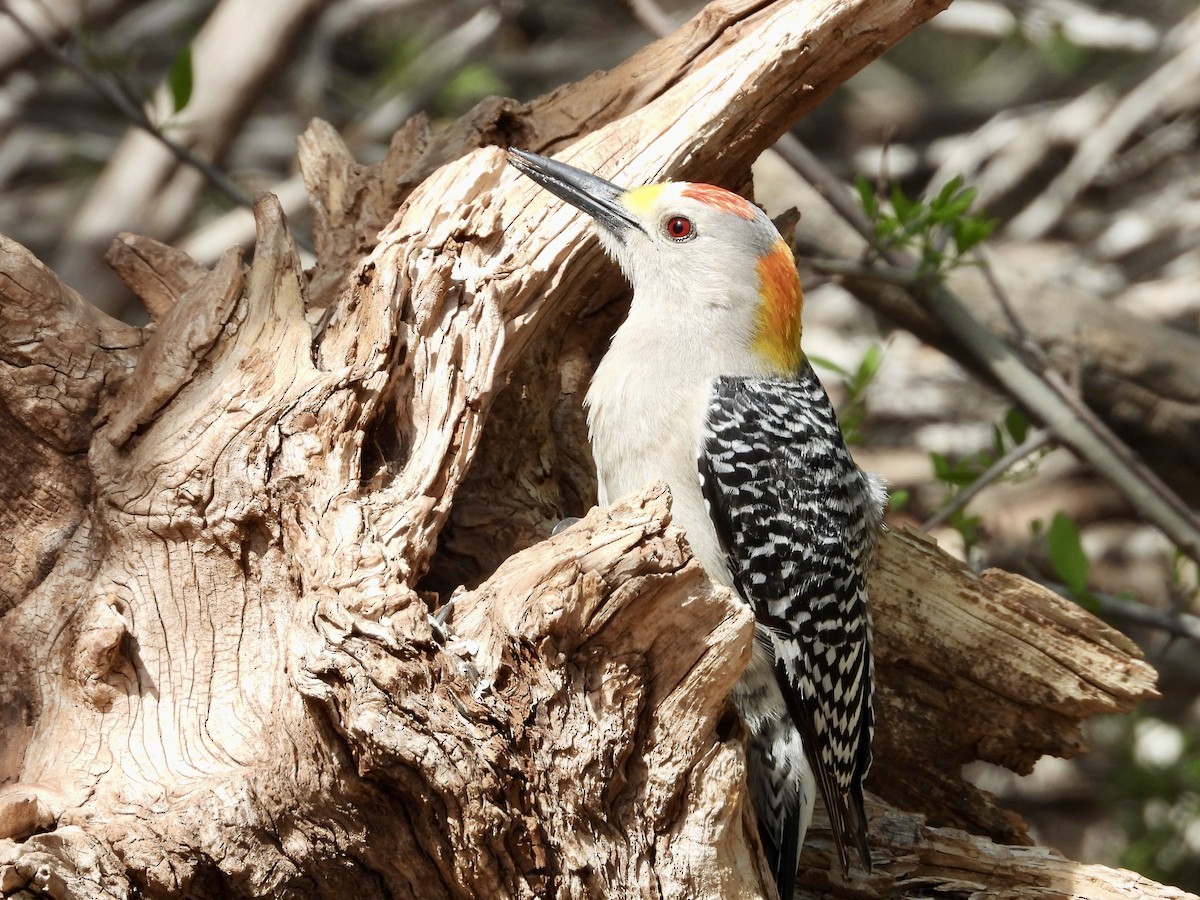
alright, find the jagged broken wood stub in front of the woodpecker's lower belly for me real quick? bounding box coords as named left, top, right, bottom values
left=295, top=487, right=764, bottom=896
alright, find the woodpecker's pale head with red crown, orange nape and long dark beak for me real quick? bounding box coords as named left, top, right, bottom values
left=509, top=150, right=803, bottom=377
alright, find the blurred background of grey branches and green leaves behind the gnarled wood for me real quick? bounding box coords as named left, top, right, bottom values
left=0, top=0, right=1200, bottom=890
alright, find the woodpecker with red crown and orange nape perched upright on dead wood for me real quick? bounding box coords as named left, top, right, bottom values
left=508, top=150, right=886, bottom=898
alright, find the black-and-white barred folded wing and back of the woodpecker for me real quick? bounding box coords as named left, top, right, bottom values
left=700, top=374, right=882, bottom=869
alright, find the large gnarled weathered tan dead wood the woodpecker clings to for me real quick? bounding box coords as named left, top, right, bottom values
left=0, top=1, right=1170, bottom=898
